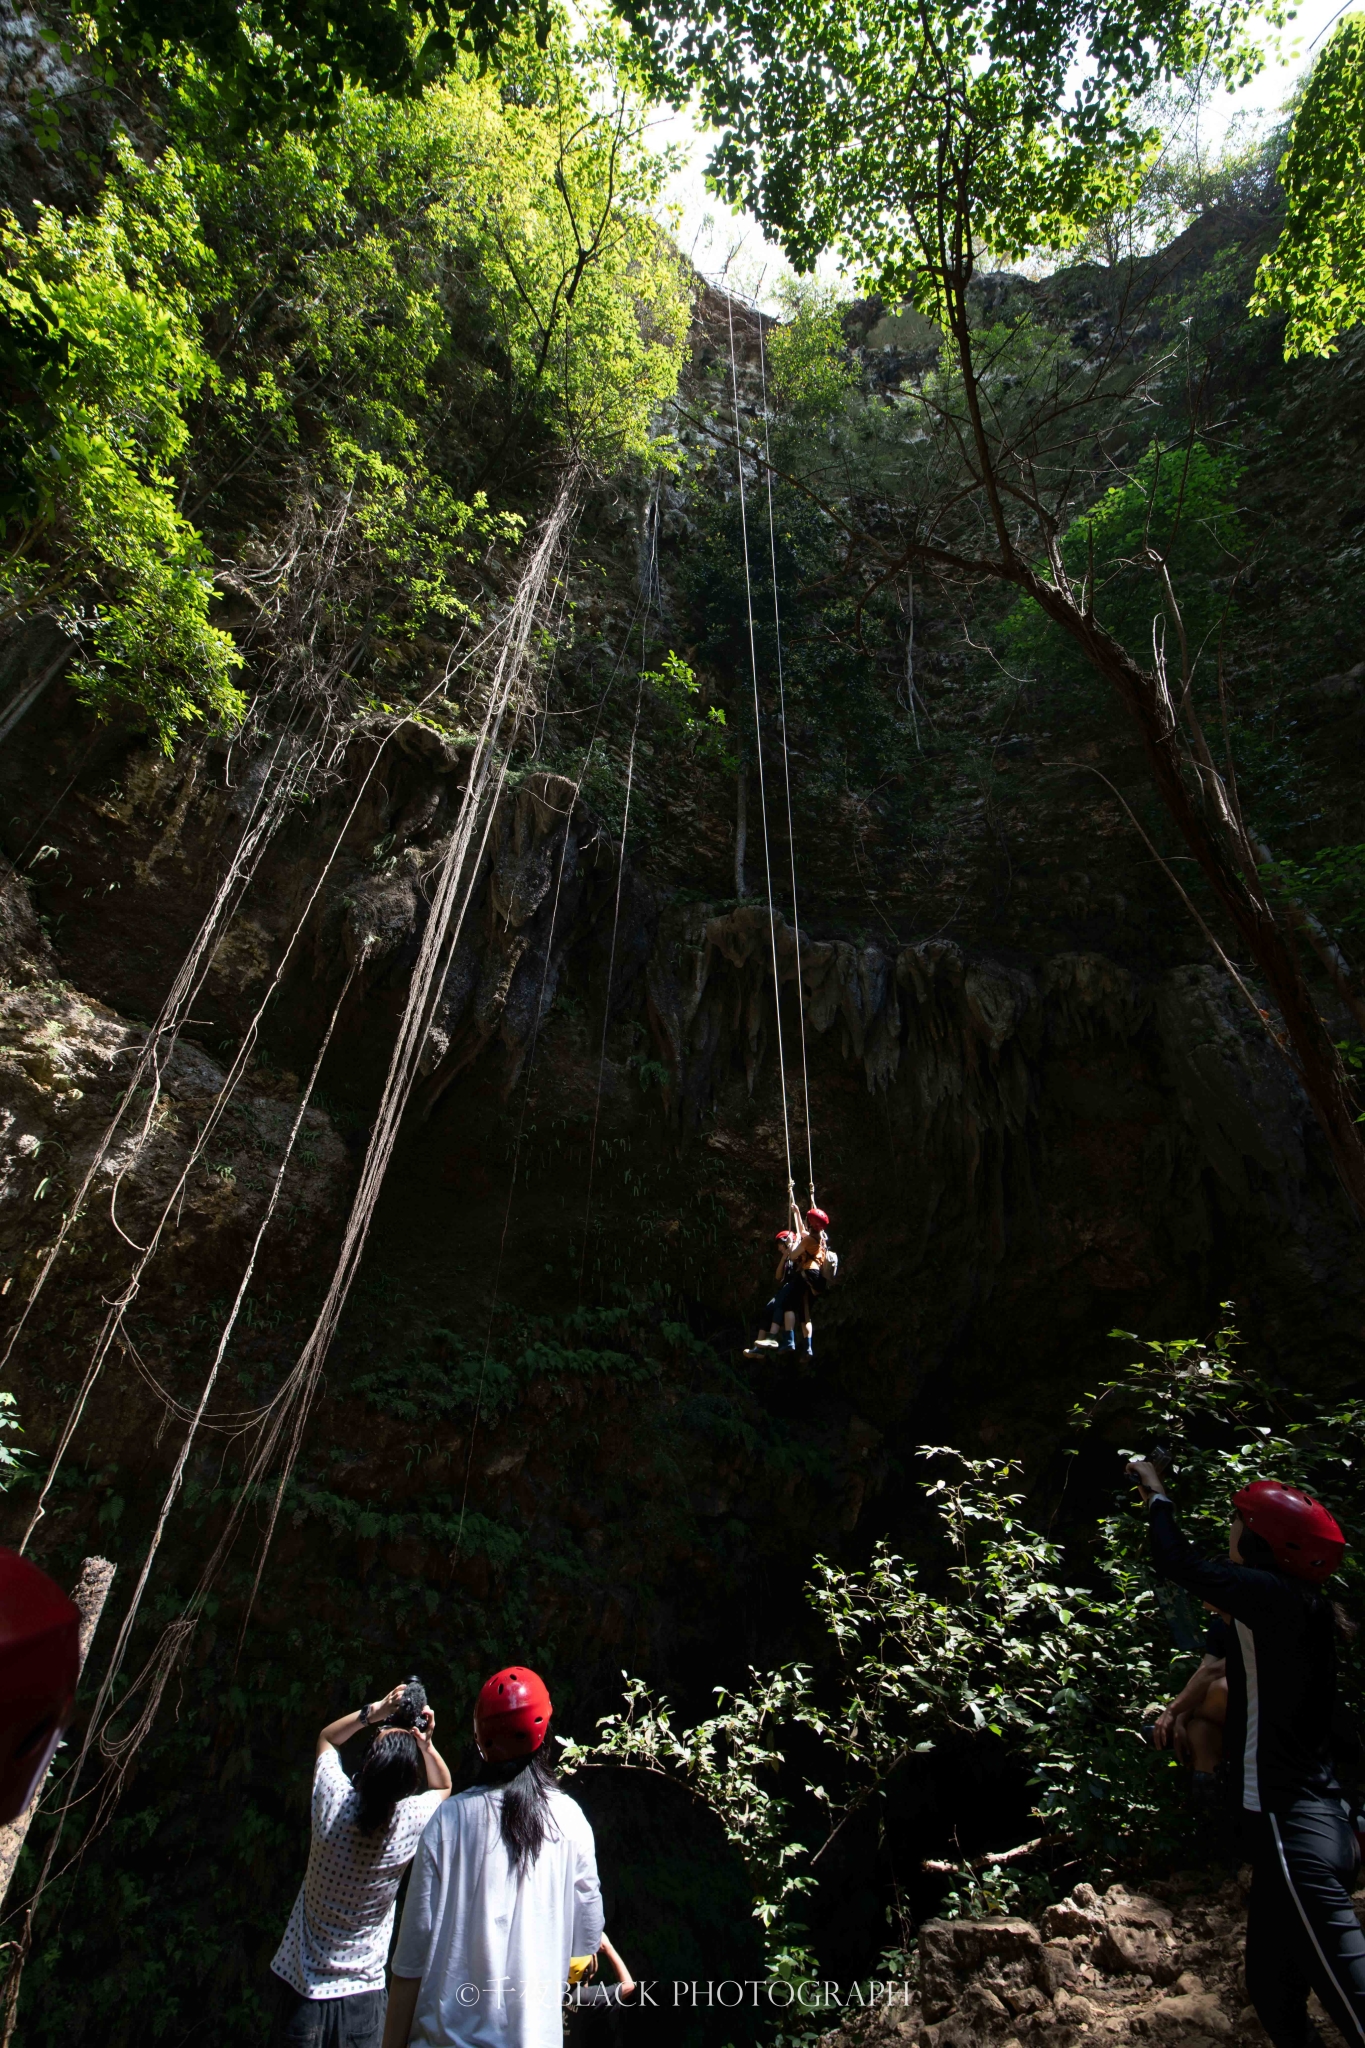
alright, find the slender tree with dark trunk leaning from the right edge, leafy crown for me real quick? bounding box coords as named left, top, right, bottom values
left=626, top=0, right=1365, bottom=1214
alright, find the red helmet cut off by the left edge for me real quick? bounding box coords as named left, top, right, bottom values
left=0, top=1550, right=80, bottom=1821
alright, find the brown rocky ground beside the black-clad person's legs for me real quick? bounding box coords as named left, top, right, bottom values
left=834, top=1868, right=1365, bottom=2048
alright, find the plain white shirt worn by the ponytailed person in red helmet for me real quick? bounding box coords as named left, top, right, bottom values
left=384, top=1786, right=602, bottom=2048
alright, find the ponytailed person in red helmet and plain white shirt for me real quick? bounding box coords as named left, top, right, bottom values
left=383, top=1665, right=602, bottom=2048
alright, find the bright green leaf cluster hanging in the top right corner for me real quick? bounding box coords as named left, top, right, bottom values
left=1250, top=14, right=1365, bottom=358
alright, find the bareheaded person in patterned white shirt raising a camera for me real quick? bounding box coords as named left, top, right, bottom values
left=270, top=1686, right=450, bottom=2048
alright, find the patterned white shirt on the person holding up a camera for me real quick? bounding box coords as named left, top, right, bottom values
left=270, top=1743, right=442, bottom=1999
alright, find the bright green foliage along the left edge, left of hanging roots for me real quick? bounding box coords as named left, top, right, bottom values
left=0, top=143, right=244, bottom=748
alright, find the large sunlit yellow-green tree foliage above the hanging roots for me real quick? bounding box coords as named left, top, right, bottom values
left=181, top=39, right=688, bottom=688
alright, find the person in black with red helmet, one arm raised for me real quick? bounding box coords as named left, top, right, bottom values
left=1128, top=1458, right=1365, bottom=2048
